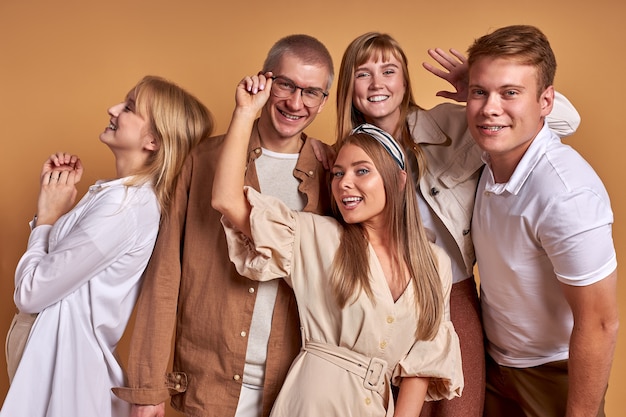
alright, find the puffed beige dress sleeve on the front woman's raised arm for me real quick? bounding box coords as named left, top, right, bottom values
left=222, top=187, right=296, bottom=285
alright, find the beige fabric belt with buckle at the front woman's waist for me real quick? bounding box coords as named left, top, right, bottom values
left=303, top=341, right=390, bottom=399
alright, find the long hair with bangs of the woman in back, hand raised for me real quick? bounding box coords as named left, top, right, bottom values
left=337, top=32, right=426, bottom=177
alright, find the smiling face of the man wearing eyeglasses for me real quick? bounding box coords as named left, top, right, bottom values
left=259, top=53, right=330, bottom=149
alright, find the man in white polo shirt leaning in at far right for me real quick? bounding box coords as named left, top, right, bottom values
left=467, top=26, right=618, bottom=417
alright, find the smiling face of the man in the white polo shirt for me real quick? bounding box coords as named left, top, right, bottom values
left=467, top=57, right=554, bottom=182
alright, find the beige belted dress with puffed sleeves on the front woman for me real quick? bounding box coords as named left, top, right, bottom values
left=224, top=188, right=463, bottom=417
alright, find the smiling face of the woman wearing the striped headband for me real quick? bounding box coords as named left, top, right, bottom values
left=332, top=144, right=386, bottom=228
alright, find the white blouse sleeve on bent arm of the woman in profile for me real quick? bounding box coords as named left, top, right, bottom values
left=14, top=187, right=152, bottom=313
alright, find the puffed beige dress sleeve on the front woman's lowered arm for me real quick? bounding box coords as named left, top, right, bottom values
left=392, top=244, right=464, bottom=401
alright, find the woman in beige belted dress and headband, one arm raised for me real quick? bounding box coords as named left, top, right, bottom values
left=213, top=74, right=463, bottom=417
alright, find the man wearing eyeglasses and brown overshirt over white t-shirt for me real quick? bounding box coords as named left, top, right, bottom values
left=114, top=35, right=333, bottom=417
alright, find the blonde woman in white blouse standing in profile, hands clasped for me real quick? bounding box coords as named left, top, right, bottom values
left=0, top=76, right=213, bottom=417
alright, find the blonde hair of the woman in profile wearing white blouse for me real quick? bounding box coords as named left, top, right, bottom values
left=127, top=75, right=213, bottom=215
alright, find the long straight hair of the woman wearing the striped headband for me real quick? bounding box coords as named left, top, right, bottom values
left=331, top=133, right=444, bottom=340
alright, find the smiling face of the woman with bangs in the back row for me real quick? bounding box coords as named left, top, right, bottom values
left=352, top=54, right=406, bottom=134
